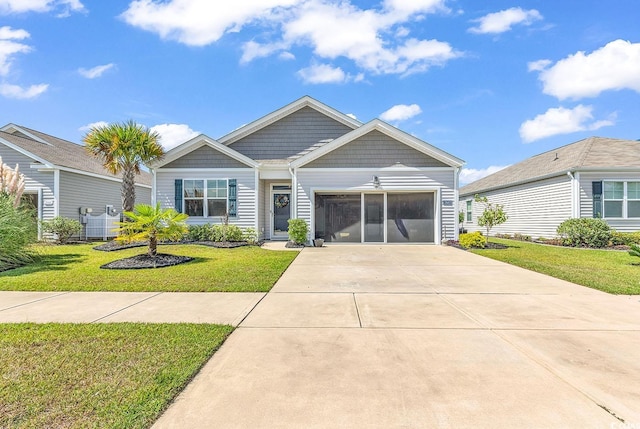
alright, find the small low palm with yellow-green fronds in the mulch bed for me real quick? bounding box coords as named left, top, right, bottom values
left=116, top=203, right=189, bottom=257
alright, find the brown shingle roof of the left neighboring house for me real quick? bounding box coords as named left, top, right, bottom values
left=0, top=124, right=151, bottom=185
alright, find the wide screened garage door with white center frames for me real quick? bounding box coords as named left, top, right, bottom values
left=315, top=192, right=435, bottom=243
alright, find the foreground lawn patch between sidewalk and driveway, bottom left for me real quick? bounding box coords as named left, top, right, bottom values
left=0, top=323, right=233, bottom=428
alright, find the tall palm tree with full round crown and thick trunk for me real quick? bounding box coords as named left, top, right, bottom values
left=82, top=120, right=164, bottom=211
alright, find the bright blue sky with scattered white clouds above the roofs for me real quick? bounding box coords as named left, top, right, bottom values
left=0, top=0, right=640, bottom=182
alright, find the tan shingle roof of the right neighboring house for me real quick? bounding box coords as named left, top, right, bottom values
left=460, top=137, right=640, bottom=195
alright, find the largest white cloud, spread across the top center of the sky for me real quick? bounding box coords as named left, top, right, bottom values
left=121, top=0, right=462, bottom=75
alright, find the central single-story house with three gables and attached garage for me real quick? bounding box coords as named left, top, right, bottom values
left=152, top=97, right=463, bottom=243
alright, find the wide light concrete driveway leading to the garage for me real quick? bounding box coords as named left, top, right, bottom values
left=154, top=246, right=640, bottom=428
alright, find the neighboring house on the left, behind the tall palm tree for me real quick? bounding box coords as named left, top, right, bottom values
left=0, top=124, right=151, bottom=239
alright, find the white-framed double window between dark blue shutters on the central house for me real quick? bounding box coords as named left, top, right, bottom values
left=183, top=179, right=230, bottom=217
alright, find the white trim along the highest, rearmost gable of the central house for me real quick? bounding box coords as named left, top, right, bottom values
left=219, top=95, right=362, bottom=146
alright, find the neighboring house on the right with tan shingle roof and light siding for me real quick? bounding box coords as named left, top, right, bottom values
left=459, top=137, right=640, bottom=238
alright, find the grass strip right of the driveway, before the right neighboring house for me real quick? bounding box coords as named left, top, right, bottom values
left=472, top=238, right=640, bottom=295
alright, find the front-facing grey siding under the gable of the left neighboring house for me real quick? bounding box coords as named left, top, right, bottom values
left=0, top=144, right=55, bottom=220
